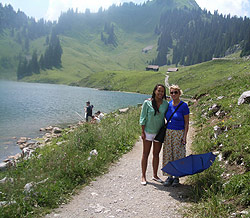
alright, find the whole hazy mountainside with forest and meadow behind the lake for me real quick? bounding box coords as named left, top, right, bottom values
left=0, top=0, right=250, bottom=87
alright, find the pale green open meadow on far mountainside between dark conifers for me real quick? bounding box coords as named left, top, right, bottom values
left=24, top=28, right=157, bottom=84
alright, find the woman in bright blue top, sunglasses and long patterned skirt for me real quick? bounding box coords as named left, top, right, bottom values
left=163, top=85, right=189, bottom=186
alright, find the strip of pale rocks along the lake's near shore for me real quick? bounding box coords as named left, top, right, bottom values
left=0, top=121, right=84, bottom=171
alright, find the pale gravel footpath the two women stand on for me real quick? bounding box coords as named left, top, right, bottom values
left=45, top=125, right=194, bottom=218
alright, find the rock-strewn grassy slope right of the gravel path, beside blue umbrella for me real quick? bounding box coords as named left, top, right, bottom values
left=186, top=64, right=250, bottom=218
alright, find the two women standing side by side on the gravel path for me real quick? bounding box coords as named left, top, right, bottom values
left=140, top=84, right=189, bottom=186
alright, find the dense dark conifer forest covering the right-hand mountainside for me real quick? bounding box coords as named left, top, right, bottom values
left=151, top=8, right=250, bottom=66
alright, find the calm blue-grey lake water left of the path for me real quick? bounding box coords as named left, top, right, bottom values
left=0, top=81, right=149, bottom=161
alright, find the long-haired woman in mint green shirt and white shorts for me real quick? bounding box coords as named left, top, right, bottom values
left=140, top=84, right=168, bottom=185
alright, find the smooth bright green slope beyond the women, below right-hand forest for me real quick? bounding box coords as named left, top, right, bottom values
left=169, top=58, right=250, bottom=96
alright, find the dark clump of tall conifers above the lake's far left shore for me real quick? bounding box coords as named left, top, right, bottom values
left=17, top=31, right=63, bottom=80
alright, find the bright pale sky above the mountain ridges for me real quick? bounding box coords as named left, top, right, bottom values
left=0, top=0, right=250, bottom=20
